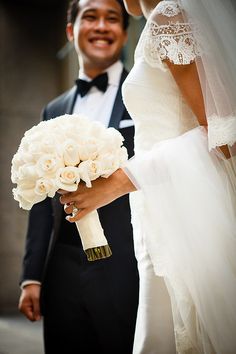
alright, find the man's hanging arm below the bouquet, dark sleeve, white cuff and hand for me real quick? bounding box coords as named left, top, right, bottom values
left=18, top=198, right=53, bottom=321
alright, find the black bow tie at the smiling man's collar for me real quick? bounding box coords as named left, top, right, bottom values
left=75, top=73, right=108, bottom=97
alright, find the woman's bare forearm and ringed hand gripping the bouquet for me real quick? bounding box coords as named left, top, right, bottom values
left=60, top=169, right=136, bottom=222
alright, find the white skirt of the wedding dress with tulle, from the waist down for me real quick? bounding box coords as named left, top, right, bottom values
left=124, top=127, right=236, bottom=354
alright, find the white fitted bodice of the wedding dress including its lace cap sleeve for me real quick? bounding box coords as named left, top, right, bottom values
left=123, top=1, right=199, bottom=151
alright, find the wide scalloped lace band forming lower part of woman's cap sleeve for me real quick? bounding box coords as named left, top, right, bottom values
left=144, top=21, right=200, bottom=67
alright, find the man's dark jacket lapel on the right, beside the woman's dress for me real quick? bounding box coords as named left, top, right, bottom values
left=109, top=69, right=128, bottom=129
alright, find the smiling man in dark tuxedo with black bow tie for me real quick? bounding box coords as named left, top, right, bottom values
left=19, top=0, right=139, bottom=354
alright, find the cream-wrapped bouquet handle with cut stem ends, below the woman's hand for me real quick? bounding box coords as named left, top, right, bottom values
left=75, top=210, right=112, bottom=261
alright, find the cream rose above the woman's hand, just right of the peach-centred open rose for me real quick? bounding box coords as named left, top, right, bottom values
left=79, top=160, right=102, bottom=188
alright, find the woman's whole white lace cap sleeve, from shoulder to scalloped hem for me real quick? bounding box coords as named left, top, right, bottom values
left=144, top=0, right=200, bottom=69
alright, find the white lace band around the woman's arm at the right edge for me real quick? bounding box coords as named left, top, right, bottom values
left=208, top=114, right=236, bottom=150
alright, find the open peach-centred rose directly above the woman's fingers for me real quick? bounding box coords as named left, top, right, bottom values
left=55, top=166, right=80, bottom=192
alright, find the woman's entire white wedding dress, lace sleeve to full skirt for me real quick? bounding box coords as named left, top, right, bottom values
left=123, top=1, right=236, bottom=354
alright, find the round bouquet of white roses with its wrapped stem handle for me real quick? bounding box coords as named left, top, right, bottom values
left=11, top=114, right=128, bottom=260
